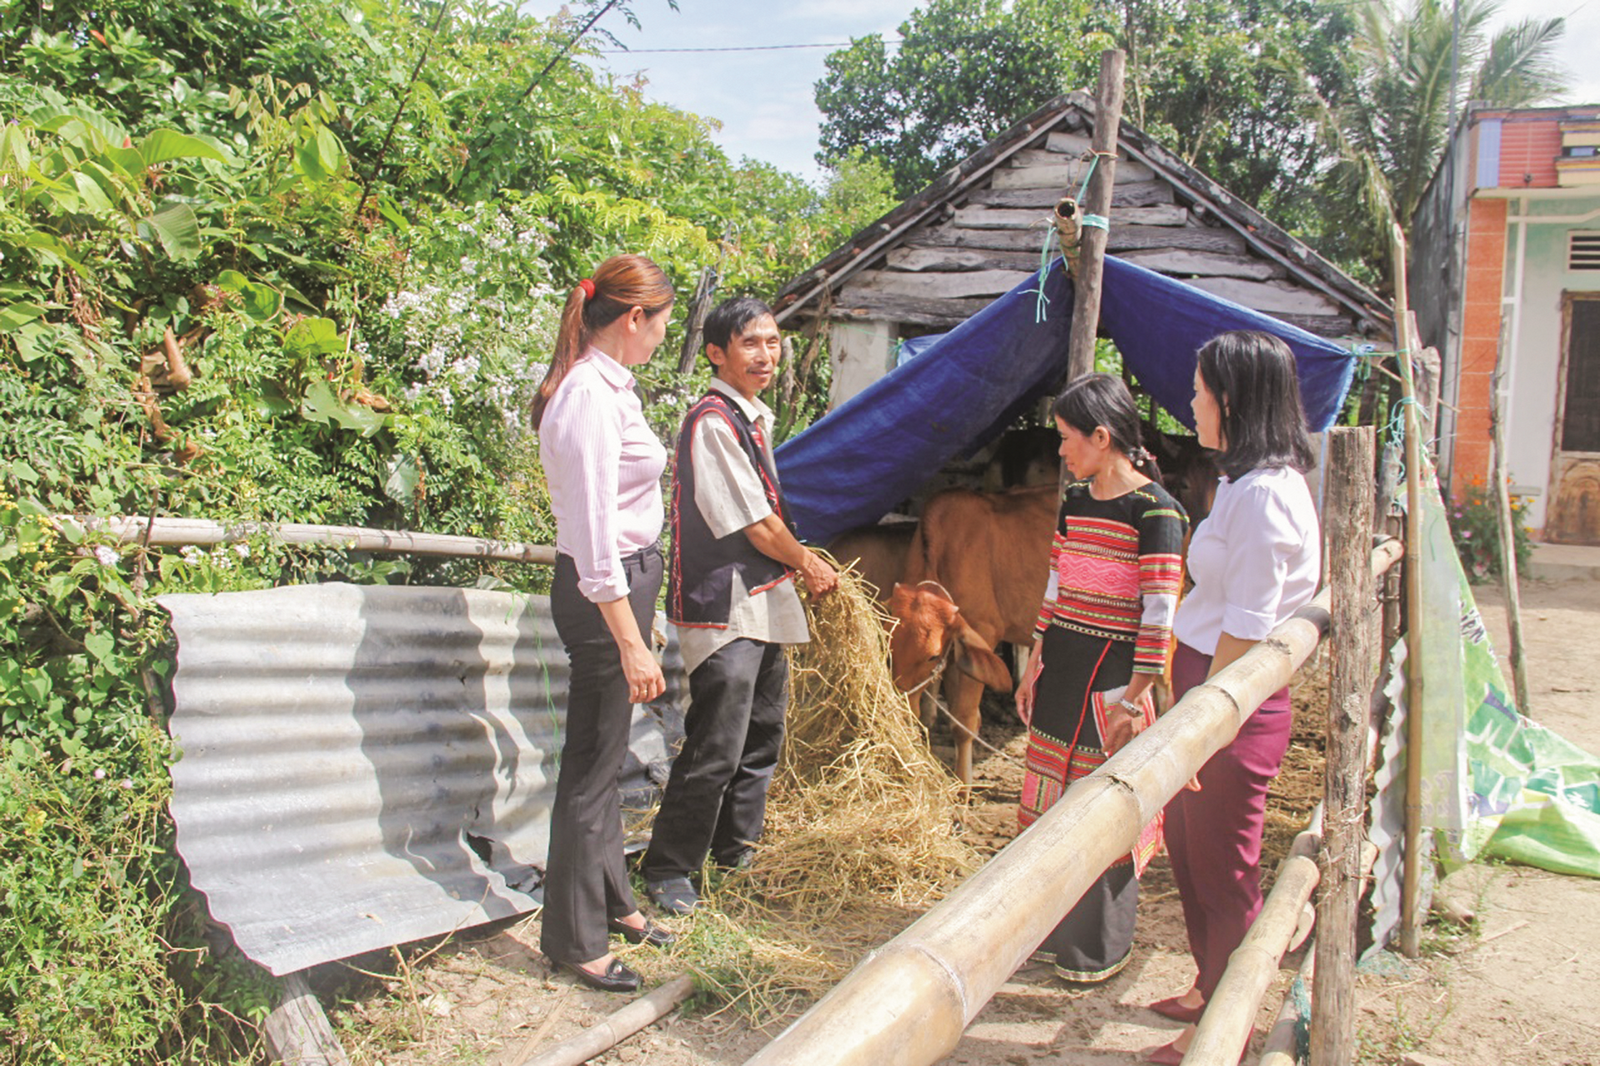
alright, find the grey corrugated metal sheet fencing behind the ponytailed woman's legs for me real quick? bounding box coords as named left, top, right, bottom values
left=160, top=584, right=686, bottom=975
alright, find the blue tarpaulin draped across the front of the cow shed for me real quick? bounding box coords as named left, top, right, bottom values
left=776, top=256, right=1355, bottom=543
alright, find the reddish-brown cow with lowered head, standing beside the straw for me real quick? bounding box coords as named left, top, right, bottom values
left=890, top=485, right=1056, bottom=784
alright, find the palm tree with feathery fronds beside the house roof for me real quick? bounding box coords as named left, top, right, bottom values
left=1306, top=0, right=1566, bottom=275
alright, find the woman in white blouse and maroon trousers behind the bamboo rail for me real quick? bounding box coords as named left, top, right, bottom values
left=1146, top=331, right=1322, bottom=1064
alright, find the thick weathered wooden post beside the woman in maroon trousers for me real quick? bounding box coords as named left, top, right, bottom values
left=1310, top=426, right=1376, bottom=1066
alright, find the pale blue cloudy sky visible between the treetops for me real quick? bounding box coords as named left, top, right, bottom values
left=522, top=0, right=1600, bottom=181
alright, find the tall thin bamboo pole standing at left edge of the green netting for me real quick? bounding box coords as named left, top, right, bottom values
left=1392, top=224, right=1424, bottom=959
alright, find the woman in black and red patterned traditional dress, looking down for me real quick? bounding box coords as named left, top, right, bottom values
left=1016, top=375, right=1187, bottom=983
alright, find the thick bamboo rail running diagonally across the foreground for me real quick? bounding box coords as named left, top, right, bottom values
left=747, top=541, right=1400, bottom=1066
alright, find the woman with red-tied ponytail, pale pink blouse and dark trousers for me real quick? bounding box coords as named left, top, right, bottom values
left=533, top=256, right=672, bottom=992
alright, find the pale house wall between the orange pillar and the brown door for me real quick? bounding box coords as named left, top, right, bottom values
left=1506, top=195, right=1600, bottom=530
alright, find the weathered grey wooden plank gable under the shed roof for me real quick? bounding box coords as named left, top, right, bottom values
left=834, top=130, right=1355, bottom=336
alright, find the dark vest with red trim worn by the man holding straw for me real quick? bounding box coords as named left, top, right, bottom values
left=667, top=392, right=790, bottom=629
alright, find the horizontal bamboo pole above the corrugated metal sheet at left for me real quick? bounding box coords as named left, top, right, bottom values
left=56, top=514, right=555, bottom=565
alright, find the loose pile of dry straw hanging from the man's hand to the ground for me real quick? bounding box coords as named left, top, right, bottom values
left=696, top=557, right=981, bottom=1018
